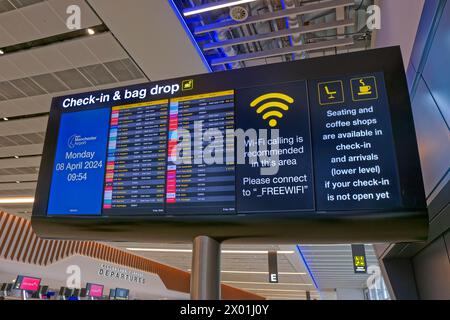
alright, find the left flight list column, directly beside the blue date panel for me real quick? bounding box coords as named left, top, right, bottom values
left=103, top=100, right=169, bottom=214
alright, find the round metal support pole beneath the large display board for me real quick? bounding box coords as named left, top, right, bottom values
left=191, top=236, right=220, bottom=300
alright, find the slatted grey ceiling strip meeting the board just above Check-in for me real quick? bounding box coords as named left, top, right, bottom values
left=0, top=58, right=144, bottom=101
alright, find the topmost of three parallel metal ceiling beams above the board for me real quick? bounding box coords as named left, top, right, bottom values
left=194, top=0, right=355, bottom=35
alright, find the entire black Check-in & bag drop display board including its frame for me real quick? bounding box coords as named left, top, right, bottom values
left=33, top=48, right=427, bottom=240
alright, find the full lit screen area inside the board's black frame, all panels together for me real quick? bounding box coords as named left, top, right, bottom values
left=47, top=72, right=401, bottom=216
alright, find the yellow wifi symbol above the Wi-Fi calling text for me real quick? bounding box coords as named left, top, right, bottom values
left=250, top=93, right=294, bottom=128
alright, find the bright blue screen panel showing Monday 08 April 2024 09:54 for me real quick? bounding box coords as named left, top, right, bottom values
left=47, top=108, right=110, bottom=215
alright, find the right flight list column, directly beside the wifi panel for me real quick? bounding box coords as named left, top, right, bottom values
left=166, top=91, right=235, bottom=214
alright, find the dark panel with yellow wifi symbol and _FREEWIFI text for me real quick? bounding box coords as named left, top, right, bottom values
left=236, top=81, right=314, bottom=212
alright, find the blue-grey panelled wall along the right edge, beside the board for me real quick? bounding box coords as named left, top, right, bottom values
left=379, top=0, right=450, bottom=299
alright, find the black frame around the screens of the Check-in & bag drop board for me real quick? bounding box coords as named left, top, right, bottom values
left=32, top=47, right=428, bottom=243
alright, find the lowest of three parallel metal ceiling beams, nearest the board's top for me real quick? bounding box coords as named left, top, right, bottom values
left=211, top=38, right=354, bottom=66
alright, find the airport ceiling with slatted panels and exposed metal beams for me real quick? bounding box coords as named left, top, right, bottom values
left=0, top=0, right=375, bottom=297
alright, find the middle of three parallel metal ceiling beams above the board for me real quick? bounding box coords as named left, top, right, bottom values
left=203, top=19, right=355, bottom=50
